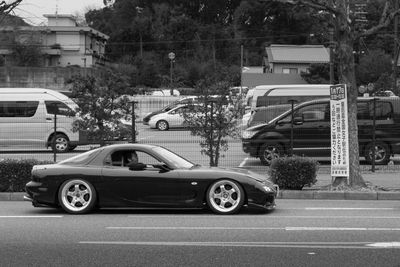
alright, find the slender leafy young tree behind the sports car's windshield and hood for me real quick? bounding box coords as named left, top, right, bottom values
left=182, top=78, right=243, bottom=166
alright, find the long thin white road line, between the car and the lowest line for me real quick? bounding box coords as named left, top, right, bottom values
left=106, top=226, right=400, bottom=231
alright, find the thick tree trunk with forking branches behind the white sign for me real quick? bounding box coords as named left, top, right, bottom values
left=275, top=0, right=400, bottom=187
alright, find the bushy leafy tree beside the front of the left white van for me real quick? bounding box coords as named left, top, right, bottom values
left=67, top=71, right=131, bottom=145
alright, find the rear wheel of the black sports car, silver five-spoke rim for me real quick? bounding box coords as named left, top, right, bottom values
left=58, top=179, right=97, bottom=214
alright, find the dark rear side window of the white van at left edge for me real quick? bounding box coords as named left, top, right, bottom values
left=0, top=101, right=39, bottom=117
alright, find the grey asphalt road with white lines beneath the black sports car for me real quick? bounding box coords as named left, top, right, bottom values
left=0, top=200, right=400, bottom=267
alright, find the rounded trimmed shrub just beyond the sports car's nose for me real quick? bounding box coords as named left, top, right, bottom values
left=269, top=156, right=319, bottom=190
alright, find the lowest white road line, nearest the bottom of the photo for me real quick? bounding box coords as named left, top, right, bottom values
left=79, top=241, right=400, bottom=249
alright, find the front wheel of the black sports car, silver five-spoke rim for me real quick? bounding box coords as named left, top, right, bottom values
left=206, top=180, right=245, bottom=214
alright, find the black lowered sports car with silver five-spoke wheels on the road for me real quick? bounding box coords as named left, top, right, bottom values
left=25, top=144, right=278, bottom=214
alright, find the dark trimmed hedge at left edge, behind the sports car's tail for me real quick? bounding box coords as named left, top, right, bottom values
left=0, top=159, right=53, bottom=192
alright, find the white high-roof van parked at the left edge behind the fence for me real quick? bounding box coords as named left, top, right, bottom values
left=0, top=88, right=84, bottom=152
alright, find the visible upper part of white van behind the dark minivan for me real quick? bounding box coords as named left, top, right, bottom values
left=249, top=84, right=330, bottom=110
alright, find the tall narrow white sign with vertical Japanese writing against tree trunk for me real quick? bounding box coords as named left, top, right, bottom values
left=330, top=84, right=349, bottom=177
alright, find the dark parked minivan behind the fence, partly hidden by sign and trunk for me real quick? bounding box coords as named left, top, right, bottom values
left=242, top=97, right=400, bottom=165
